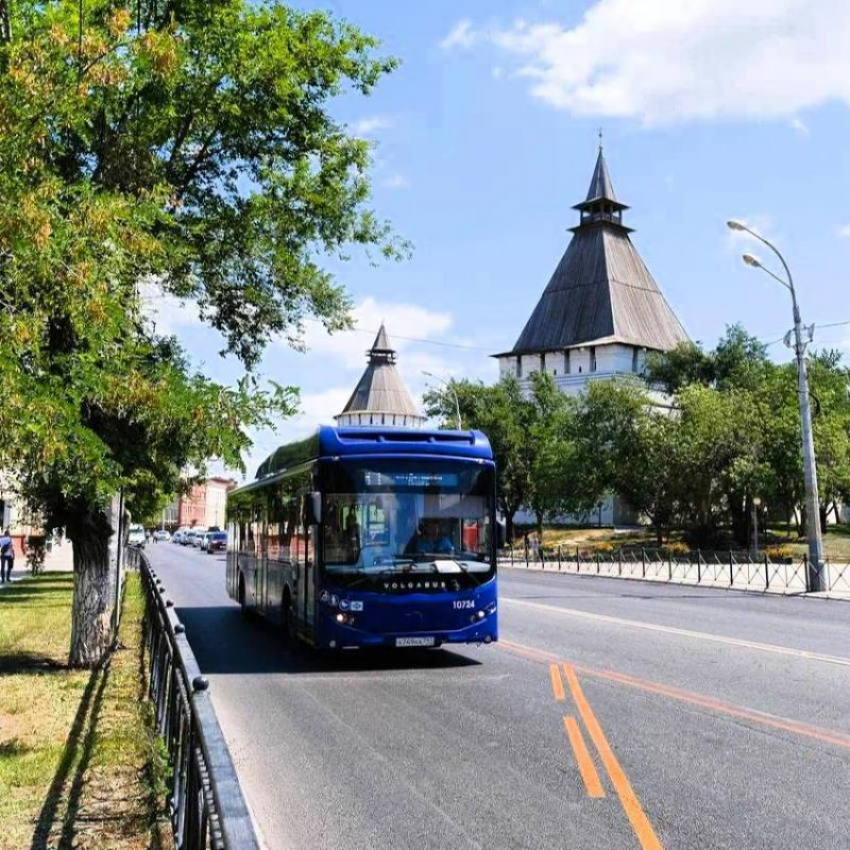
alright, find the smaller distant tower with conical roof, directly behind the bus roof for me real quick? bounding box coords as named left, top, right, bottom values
left=334, top=325, right=425, bottom=428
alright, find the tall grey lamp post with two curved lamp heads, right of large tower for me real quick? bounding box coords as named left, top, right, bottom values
left=726, top=220, right=829, bottom=590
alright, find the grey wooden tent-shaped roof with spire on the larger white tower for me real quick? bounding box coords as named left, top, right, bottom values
left=497, top=149, right=688, bottom=356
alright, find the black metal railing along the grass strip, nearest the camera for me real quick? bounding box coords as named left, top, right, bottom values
left=136, top=549, right=260, bottom=850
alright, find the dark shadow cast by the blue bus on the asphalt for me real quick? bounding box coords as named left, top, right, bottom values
left=175, top=605, right=481, bottom=674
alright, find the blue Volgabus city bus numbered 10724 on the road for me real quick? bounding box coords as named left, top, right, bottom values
left=227, top=427, right=499, bottom=650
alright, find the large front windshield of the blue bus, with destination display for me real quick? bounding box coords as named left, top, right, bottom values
left=322, top=459, right=494, bottom=583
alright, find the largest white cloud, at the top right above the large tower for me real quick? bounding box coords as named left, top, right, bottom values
left=442, top=0, right=850, bottom=123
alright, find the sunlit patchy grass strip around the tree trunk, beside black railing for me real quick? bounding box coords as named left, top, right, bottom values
left=0, top=573, right=169, bottom=850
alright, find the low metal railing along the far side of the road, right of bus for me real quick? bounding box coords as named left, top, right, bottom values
left=499, top=545, right=850, bottom=596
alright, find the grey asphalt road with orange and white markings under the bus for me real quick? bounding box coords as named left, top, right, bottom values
left=147, top=543, right=850, bottom=850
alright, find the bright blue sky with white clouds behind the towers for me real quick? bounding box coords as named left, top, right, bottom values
left=161, top=0, right=850, bottom=472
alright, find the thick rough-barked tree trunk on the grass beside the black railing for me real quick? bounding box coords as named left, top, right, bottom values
left=68, top=504, right=115, bottom=668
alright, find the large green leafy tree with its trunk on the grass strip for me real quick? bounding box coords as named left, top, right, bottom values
left=0, top=0, right=398, bottom=666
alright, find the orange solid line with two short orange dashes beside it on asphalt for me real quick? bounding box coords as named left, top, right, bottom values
left=549, top=652, right=661, bottom=850
